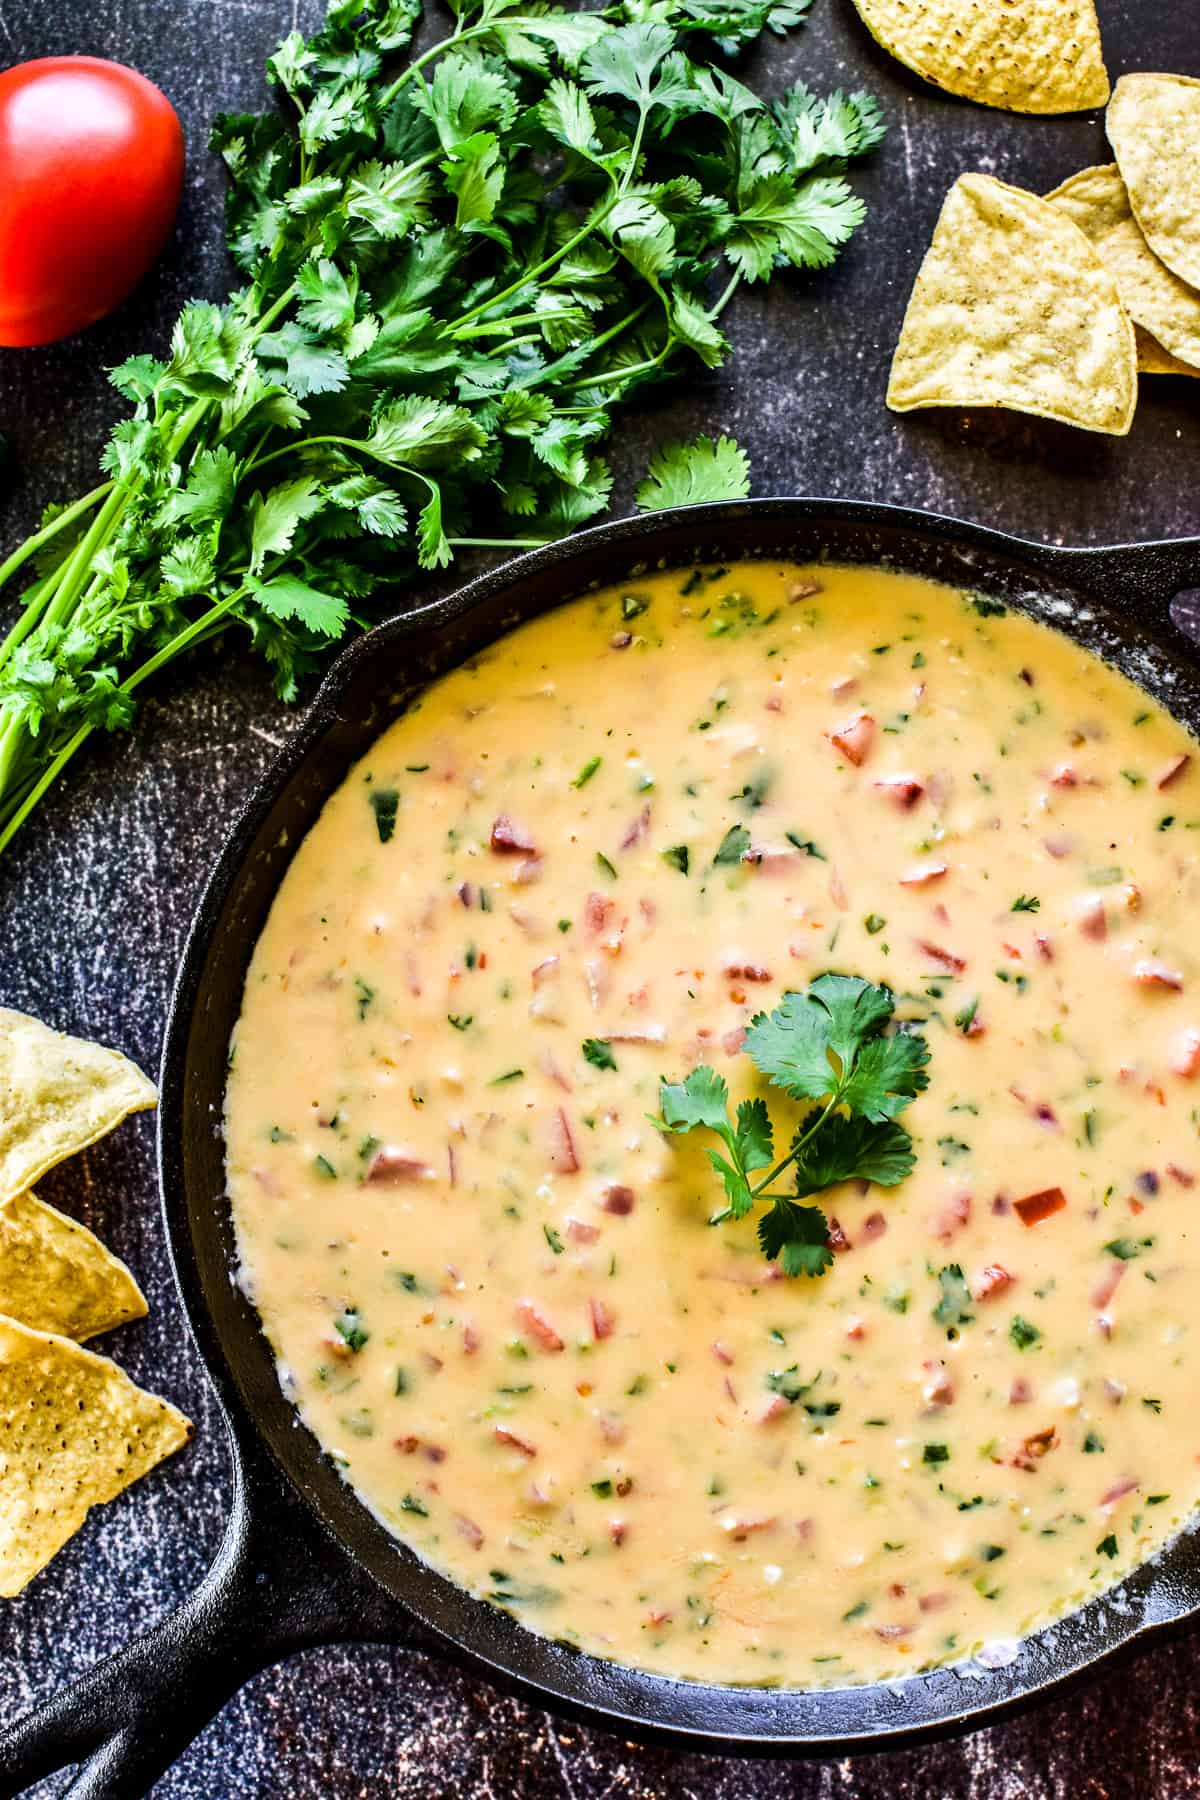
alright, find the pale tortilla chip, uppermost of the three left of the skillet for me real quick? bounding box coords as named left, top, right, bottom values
left=0, top=1008, right=158, bottom=1204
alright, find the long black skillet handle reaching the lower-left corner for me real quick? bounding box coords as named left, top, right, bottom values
left=0, top=1425, right=434, bottom=1800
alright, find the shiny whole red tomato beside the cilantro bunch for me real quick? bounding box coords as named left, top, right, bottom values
left=0, top=56, right=184, bottom=346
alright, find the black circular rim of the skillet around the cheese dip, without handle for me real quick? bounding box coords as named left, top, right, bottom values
left=158, top=497, right=1200, bottom=1755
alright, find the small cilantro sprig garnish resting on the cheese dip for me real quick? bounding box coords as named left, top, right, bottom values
left=655, top=974, right=928, bottom=1276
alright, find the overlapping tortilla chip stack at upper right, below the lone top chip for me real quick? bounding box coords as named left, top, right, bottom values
left=887, top=76, right=1200, bottom=437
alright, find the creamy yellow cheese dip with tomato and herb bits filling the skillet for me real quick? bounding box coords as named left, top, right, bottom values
left=227, top=563, right=1200, bottom=1685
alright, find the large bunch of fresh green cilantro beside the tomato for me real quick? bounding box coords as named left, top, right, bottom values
left=0, top=0, right=882, bottom=850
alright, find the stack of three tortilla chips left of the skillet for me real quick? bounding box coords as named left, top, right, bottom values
left=0, top=1008, right=191, bottom=1598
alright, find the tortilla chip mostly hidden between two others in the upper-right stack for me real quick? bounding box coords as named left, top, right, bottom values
left=1045, top=162, right=1200, bottom=369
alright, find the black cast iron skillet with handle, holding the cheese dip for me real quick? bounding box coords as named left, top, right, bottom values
left=0, top=500, right=1200, bottom=1800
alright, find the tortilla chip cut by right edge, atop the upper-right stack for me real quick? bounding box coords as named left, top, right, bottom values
left=1106, top=76, right=1200, bottom=288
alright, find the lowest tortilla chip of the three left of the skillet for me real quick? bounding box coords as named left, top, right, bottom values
left=0, top=1318, right=193, bottom=1598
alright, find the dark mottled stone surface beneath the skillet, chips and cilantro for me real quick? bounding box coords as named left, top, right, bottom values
left=0, top=0, right=1200, bottom=1800
